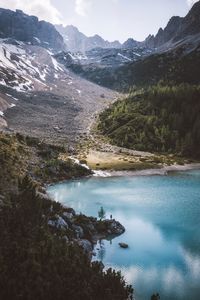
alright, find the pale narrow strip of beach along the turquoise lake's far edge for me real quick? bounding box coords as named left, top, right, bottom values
left=92, top=163, right=200, bottom=178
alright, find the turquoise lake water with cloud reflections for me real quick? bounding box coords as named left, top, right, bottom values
left=48, top=170, right=200, bottom=300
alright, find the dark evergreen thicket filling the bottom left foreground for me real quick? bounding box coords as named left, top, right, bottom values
left=0, top=177, right=132, bottom=300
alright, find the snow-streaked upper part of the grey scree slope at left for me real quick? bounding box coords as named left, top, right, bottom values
left=0, top=40, right=63, bottom=92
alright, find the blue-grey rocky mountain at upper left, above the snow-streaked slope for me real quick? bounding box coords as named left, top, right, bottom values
left=0, top=8, right=65, bottom=51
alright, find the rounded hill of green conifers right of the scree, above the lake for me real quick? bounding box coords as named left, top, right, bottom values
left=98, top=84, right=200, bottom=158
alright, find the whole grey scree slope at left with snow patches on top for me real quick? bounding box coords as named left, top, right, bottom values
left=0, top=35, right=115, bottom=142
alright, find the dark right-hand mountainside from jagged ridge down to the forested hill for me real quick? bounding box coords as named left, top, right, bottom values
left=69, top=1, right=200, bottom=91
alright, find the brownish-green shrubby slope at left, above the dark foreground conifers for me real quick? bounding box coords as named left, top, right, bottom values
left=0, top=133, right=90, bottom=193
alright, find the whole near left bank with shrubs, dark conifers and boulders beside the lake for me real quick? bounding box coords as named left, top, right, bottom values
left=0, top=133, right=133, bottom=300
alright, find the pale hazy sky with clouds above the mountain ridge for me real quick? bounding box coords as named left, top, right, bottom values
left=0, top=0, right=197, bottom=42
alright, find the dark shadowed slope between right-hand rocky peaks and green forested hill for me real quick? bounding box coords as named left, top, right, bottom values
left=113, top=47, right=200, bottom=90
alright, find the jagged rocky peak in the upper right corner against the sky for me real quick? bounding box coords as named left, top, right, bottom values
left=145, top=1, right=200, bottom=49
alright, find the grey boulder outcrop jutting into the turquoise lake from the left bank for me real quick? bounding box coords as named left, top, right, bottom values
left=41, top=190, right=125, bottom=258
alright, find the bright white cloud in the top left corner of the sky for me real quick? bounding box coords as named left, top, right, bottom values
left=0, top=0, right=62, bottom=24
